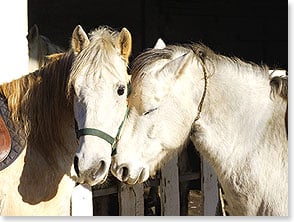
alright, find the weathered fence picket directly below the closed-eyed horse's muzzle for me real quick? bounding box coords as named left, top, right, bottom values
left=118, top=183, right=144, bottom=216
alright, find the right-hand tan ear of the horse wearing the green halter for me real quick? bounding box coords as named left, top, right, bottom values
left=118, top=28, right=132, bottom=63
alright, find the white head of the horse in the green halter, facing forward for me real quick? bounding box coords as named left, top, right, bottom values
left=69, top=26, right=132, bottom=185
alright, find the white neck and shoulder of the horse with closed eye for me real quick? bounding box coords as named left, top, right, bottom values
left=191, top=65, right=288, bottom=215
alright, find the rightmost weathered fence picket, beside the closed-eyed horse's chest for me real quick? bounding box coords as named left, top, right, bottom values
left=201, top=156, right=219, bottom=216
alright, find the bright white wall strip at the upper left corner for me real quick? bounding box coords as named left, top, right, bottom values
left=0, top=0, right=28, bottom=84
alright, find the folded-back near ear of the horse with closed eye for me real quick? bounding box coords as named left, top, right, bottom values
left=159, top=53, right=192, bottom=78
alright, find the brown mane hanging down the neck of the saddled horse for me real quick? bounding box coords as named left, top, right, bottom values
left=0, top=51, right=74, bottom=162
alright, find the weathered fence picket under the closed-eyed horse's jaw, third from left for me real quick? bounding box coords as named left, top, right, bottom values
left=160, top=155, right=180, bottom=216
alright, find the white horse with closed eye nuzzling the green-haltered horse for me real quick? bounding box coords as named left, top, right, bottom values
left=111, top=41, right=288, bottom=216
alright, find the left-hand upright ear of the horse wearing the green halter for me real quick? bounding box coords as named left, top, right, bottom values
left=71, top=25, right=90, bottom=53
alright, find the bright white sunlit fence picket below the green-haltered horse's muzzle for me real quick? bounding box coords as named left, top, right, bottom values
left=71, top=184, right=93, bottom=216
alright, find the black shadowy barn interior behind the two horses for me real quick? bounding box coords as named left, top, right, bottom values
left=28, top=0, right=288, bottom=215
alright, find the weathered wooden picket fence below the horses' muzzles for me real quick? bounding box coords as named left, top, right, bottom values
left=72, top=143, right=219, bottom=216
